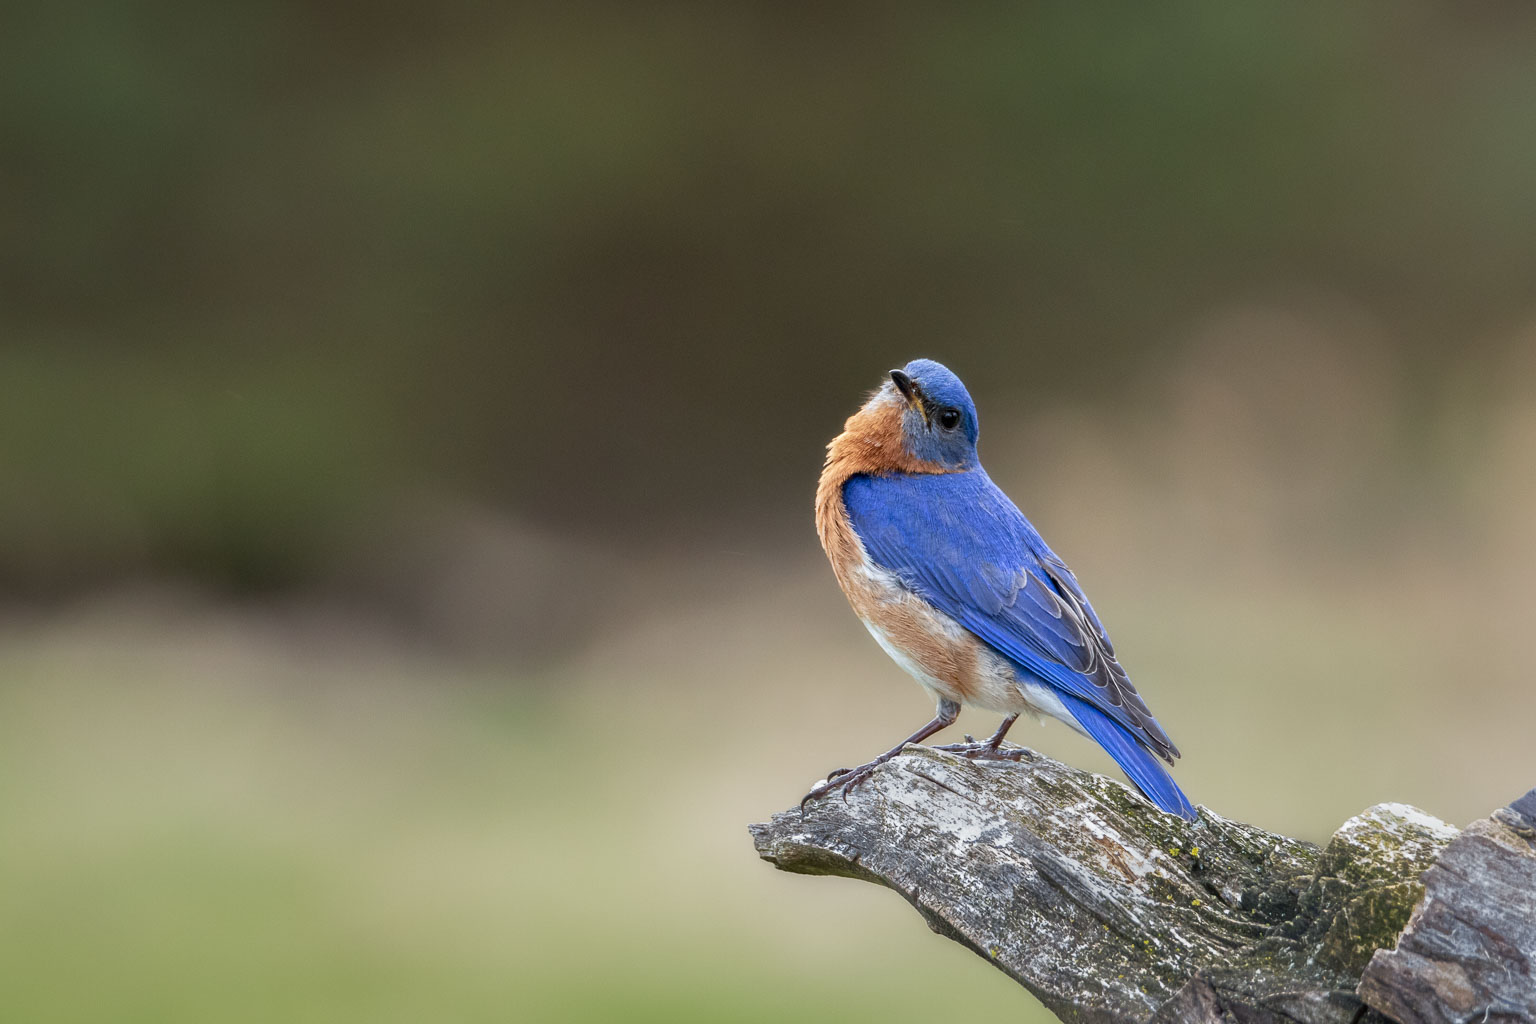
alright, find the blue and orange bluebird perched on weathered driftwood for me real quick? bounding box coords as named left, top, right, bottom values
left=802, top=359, right=1195, bottom=820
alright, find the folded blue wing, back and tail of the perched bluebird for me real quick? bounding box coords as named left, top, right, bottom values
left=843, top=468, right=1189, bottom=814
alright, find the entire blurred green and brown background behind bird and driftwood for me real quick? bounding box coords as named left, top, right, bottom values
left=9, top=0, right=1536, bottom=1022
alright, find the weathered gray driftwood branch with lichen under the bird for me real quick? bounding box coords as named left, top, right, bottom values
left=751, top=746, right=1536, bottom=1024
